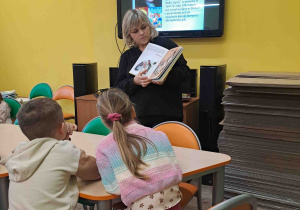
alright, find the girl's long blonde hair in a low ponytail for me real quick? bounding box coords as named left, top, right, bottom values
left=97, top=88, right=156, bottom=179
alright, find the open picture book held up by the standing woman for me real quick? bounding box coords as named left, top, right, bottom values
left=129, top=43, right=183, bottom=82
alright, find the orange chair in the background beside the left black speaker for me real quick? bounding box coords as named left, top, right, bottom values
left=53, top=85, right=75, bottom=120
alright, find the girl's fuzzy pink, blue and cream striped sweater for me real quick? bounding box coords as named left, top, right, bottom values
left=96, top=122, right=182, bottom=206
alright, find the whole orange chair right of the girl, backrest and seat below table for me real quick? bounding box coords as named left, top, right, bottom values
left=153, top=121, right=202, bottom=210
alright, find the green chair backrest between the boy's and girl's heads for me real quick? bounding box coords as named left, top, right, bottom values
left=82, top=117, right=111, bottom=136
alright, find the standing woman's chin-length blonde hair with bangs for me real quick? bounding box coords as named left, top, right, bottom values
left=122, top=9, right=158, bottom=47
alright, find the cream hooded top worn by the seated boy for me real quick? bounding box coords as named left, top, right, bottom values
left=0, top=138, right=80, bottom=210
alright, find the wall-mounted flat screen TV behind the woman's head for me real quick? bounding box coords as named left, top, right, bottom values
left=117, top=0, right=225, bottom=39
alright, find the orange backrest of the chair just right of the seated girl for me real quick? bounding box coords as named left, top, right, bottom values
left=153, top=121, right=201, bottom=150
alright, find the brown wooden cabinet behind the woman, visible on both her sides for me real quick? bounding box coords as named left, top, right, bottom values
left=76, top=94, right=199, bottom=134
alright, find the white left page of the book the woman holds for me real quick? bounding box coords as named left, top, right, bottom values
left=129, top=43, right=168, bottom=77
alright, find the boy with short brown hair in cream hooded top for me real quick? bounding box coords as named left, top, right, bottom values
left=0, top=98, right=100, bottom=210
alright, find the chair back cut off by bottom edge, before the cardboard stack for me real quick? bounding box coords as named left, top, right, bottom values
left=208, top=194, right=257, bottom=210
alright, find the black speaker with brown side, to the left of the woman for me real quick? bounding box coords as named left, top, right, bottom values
left=73, top=63, right=98, bottom=124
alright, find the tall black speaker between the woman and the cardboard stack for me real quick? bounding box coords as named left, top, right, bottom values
left=199, top=65, right=226, bottom=152
